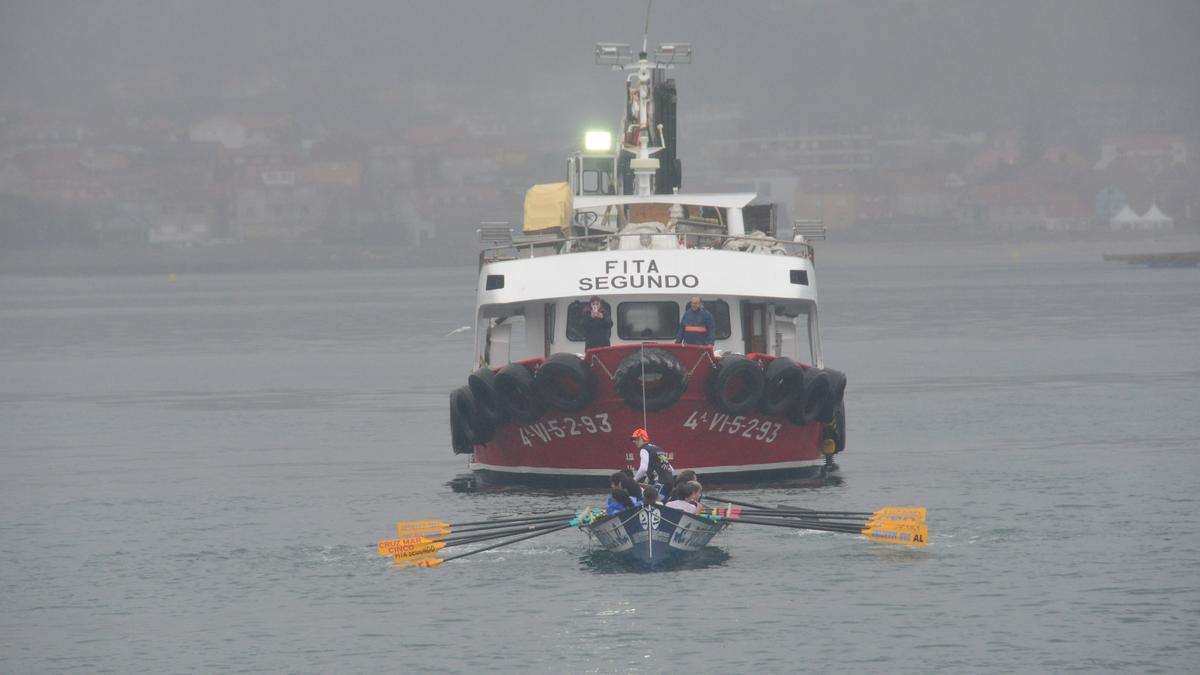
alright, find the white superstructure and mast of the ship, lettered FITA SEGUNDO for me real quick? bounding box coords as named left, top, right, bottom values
left=475, top=44, right=823, bottom=368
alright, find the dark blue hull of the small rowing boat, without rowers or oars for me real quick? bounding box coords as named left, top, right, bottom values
left=581, top=506, right=728, bottom=567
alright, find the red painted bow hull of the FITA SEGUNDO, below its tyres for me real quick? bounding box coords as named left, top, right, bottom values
left=470, top=345, right=826, bottom=484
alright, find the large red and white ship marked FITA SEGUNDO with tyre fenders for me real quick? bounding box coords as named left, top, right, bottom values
left=450, top=38, right=846, bottom=482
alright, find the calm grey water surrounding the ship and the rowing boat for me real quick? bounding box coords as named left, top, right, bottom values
left=0, top=244, right=1200, bottom=673
